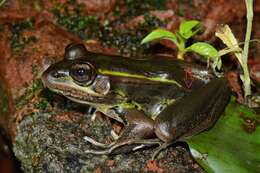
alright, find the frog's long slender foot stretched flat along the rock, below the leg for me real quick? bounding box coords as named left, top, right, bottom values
left=85, top=138, right=162, bottom=155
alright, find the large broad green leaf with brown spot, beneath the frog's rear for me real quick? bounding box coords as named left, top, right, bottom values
left=187, top=101, right=260, bottom=173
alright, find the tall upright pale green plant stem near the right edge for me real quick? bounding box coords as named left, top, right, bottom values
left=241, top=0, right=254, bottom=100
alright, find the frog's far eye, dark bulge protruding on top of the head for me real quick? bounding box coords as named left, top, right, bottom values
left=64, top=43, right=88, bottom=60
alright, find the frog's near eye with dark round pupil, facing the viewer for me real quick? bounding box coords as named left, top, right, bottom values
left=70, top=63, right=96, bottom=86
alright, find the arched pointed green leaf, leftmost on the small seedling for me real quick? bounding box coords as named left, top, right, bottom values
left=141, top=28, right=178, bottom=46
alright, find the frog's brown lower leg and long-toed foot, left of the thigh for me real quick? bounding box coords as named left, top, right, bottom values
left=85, top=109, right=160, bottom=154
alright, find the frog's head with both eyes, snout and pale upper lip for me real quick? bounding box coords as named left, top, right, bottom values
left=42, top=44, right=118, bottom=104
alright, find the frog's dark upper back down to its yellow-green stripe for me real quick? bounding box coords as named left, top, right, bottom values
left=85, top=53, right=214, bottom=89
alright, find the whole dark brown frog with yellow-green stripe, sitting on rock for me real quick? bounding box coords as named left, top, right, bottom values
left=42, top=44, right=231, bottom=158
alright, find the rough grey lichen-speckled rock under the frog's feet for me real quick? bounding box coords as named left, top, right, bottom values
left=14, top=110, right=203, bottom=173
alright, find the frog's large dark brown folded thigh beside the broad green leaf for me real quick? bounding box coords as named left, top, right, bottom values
left=154, top=78, right=231, bottom=143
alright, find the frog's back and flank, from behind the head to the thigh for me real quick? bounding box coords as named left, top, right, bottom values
left=82, top=54, right=213, bottom=118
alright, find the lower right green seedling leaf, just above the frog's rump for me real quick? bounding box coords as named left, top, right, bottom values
left=186, top=42, right=218, bottom=58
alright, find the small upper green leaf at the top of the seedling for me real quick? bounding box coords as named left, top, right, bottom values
left=179, top=20, right=200, bottom=39
